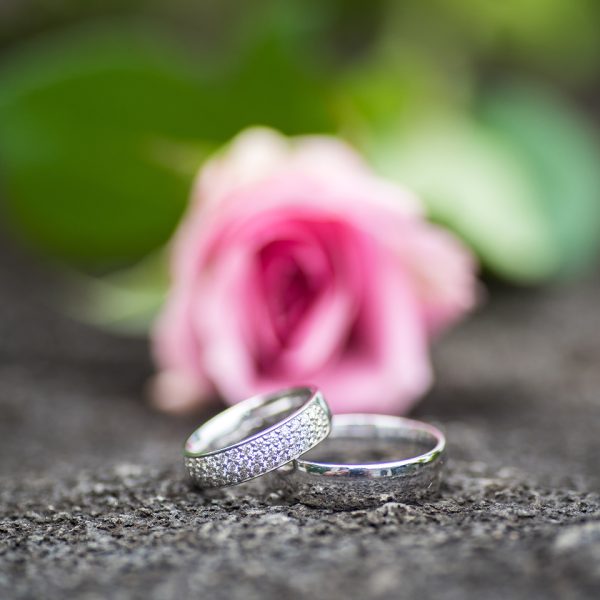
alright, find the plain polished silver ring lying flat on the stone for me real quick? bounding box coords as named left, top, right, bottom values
left=271, top=414, right=446, bottom=509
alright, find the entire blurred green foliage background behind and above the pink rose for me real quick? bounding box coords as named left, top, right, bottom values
left=0, top=0, right=600, bottom=328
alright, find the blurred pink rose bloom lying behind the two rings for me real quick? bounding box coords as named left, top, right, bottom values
left=154, top=129, right=475, bottom=413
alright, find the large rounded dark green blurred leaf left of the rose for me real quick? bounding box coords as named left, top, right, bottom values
left=0, top=25, right=217, bottom=265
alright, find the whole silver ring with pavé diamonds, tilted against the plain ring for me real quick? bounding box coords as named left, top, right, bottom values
left=184, top=387, right=331, bottom=488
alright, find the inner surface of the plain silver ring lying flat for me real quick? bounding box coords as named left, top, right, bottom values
left=299, top=423, right=438, bottom=466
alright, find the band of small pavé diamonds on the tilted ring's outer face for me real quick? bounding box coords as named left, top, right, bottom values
left=185, top=404, right=330, bottom=487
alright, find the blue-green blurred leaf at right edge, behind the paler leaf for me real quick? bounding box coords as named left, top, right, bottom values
left=482, top=84, right=600, bottom=275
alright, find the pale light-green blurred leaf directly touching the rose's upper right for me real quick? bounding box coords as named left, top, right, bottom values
left=371, top=116, right=559, bottom=282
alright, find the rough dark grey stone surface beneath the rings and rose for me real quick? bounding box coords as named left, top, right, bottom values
left=0, top=237, right=600, bottom=600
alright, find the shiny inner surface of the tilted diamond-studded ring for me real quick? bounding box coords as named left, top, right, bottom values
left=185, top=388, right=312, bottom=454
